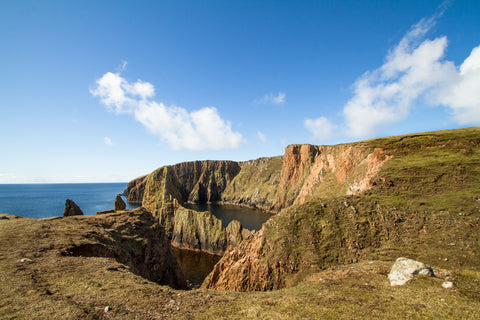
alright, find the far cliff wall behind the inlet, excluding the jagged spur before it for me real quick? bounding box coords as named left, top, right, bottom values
left=130, top=143, right=392, bottom=213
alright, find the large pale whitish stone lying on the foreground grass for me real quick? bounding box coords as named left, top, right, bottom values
left=388, top=257, right=433, bottom=286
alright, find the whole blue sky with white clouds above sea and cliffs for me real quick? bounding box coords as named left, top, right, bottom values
left=0, top=0, right=480, bottom=183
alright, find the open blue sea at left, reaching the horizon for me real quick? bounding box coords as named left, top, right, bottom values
left=0, top=183, right=138, bottom=219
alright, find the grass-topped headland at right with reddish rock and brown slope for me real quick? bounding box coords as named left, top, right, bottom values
left=203, top=128, right=480, bottom=291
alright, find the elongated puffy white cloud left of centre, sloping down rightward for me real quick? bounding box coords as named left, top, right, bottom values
left=90, top=72, right=243, bottom=151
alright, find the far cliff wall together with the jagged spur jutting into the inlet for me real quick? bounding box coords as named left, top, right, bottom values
left=125, top=145, right=391, bottom=254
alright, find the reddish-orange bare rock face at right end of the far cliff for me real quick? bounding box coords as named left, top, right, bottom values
left=273, top=144, right=392, bottom=211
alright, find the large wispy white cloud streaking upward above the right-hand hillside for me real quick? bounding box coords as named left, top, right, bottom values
left=304, top=8, right=480, bottom=140
